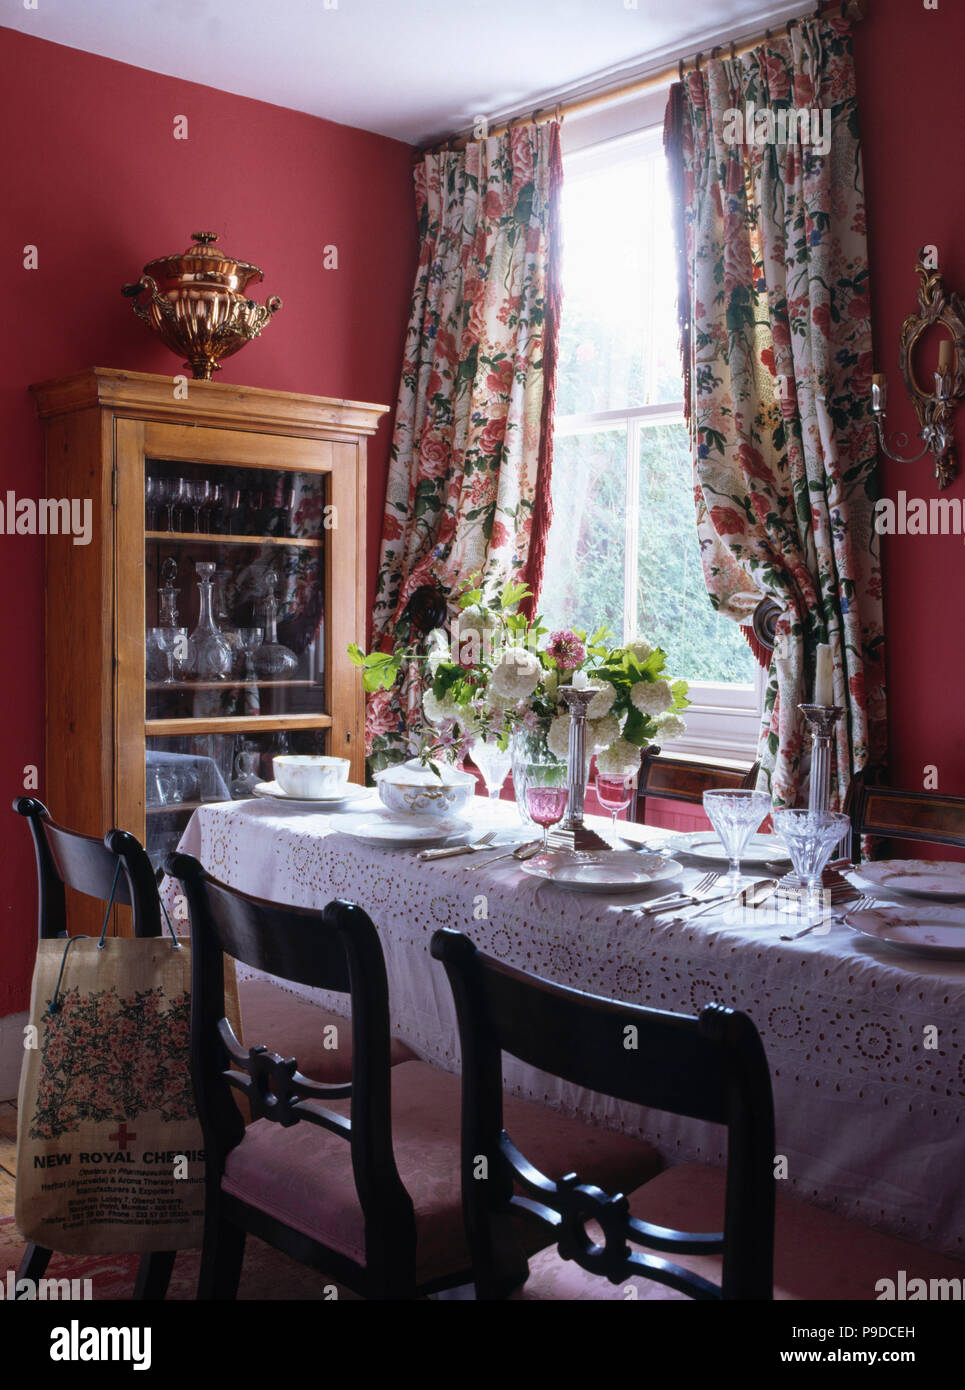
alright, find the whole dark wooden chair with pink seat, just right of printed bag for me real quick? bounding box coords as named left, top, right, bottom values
left=167, top=855, right=658, bottom=1298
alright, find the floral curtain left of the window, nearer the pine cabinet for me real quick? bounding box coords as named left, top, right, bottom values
left=366, top=122, right=562, bottom=766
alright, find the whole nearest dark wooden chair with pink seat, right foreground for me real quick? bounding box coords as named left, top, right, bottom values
left=431, top=930, right=965, bottom=1301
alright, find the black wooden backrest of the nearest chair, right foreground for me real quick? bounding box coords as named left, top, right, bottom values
left=431, top=929, right=775, bottom=1298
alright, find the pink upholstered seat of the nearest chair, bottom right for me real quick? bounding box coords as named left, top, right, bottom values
left=513, top=1163, right=965, bottom=1301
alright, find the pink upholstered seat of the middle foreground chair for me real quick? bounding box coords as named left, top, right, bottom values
left=221, top=1062, right=659, bottom=1283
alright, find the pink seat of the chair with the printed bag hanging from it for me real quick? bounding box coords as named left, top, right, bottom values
left=238, top=980, right=416, bottom=1084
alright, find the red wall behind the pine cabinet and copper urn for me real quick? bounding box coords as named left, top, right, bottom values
left=0, top=29, right=416, bottom=1016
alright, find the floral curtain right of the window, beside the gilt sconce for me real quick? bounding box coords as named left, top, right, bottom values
left=666, top=18, right=884, bottom=806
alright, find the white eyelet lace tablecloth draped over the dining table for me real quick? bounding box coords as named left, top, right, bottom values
left=165, top=802, right=965, bottom=1258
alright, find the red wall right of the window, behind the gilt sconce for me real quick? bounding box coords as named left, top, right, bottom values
left=855, top=0, right=965, bottom=795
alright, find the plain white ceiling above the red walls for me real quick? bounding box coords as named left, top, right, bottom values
left=0, top=0, right=806, bottom=143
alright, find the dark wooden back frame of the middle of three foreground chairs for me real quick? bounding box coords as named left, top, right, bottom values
left=165, top=853, right=416, bottom=1273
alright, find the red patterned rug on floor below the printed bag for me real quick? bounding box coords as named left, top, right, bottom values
left=0, top=1216, right=356, bottom=1301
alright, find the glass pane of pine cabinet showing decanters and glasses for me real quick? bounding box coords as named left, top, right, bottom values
left=143, top=457, right=331, bottom=867
